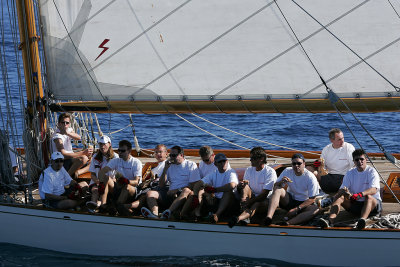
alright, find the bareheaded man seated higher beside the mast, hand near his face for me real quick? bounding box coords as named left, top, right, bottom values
left=51, top=113, right=93, bottom=178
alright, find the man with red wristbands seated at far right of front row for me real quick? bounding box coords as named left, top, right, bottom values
left=319, top=149, right=382, bottom=229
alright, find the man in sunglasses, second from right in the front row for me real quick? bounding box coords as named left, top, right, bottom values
left=264, top=153, right=319, bottom=226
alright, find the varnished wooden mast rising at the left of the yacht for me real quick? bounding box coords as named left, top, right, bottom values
left=16, top=0, right=48, bottom=168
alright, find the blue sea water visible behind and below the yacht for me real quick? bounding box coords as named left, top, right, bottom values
left=0, top=1, right=400, bottom=266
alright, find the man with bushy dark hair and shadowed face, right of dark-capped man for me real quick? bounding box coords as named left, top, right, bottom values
left=228, top=147, right=277, bottom=228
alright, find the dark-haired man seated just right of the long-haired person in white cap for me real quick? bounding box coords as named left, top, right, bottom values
left=98, top=140, right=142, bottom=213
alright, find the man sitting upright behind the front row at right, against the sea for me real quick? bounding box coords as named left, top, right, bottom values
left=317, top=128, right=354, bottom=193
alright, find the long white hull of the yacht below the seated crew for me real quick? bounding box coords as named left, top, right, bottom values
left=0, top=205, right=400, bottom=266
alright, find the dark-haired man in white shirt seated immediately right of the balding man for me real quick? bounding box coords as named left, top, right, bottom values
left=142, top=146, right=200, bottom=219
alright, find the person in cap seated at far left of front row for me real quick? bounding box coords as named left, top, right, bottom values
left=39, top=152, right=88, bottom=210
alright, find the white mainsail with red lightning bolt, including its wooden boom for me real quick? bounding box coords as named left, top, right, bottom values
left=40, top=0, right=400, bottom=113
